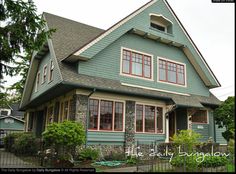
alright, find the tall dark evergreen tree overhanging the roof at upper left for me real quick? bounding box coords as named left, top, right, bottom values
left=0, top=0, right=54, bottom=102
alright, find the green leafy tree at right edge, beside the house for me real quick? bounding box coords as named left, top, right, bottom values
left=214, top=97, right=235, bottom=141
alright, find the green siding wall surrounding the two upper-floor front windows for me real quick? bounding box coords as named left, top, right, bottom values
left=78, top=34, right=209, bottom=96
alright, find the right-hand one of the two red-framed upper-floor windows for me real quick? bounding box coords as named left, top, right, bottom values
left=159, top=59, right=186, bottom=86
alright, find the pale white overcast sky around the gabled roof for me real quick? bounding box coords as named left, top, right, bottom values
left=1, top=0, right=235, bottom=101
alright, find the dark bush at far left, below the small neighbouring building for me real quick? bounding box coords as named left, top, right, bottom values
left=4, top=132, right=23, bottom=152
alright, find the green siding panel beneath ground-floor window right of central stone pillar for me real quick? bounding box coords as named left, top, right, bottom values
left=134, top=133, right=166, bottom=144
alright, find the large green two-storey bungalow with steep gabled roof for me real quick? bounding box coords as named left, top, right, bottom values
left=21, top=0, right=226, bottom=152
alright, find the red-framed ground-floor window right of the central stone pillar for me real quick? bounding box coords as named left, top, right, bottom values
left=135, top=104, right=163, bottom=133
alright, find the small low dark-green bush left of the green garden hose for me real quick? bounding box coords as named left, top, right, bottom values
left=78, top=147, right=99, bottom=161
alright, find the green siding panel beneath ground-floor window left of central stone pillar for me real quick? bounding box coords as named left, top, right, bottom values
left=88, top=131, right=125, bottom=145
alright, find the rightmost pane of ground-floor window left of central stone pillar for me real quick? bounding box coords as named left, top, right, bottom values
left=114, top=102, right=123, bottom=131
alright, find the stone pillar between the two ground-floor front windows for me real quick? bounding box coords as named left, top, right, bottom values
left=125, top=101, right=135, bottom=151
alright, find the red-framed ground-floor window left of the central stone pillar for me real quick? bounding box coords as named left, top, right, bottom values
left=88, top=99, right=124, bottom=131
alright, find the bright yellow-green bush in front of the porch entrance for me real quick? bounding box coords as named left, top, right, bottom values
left=172, top=130, right=201, bottom=151
